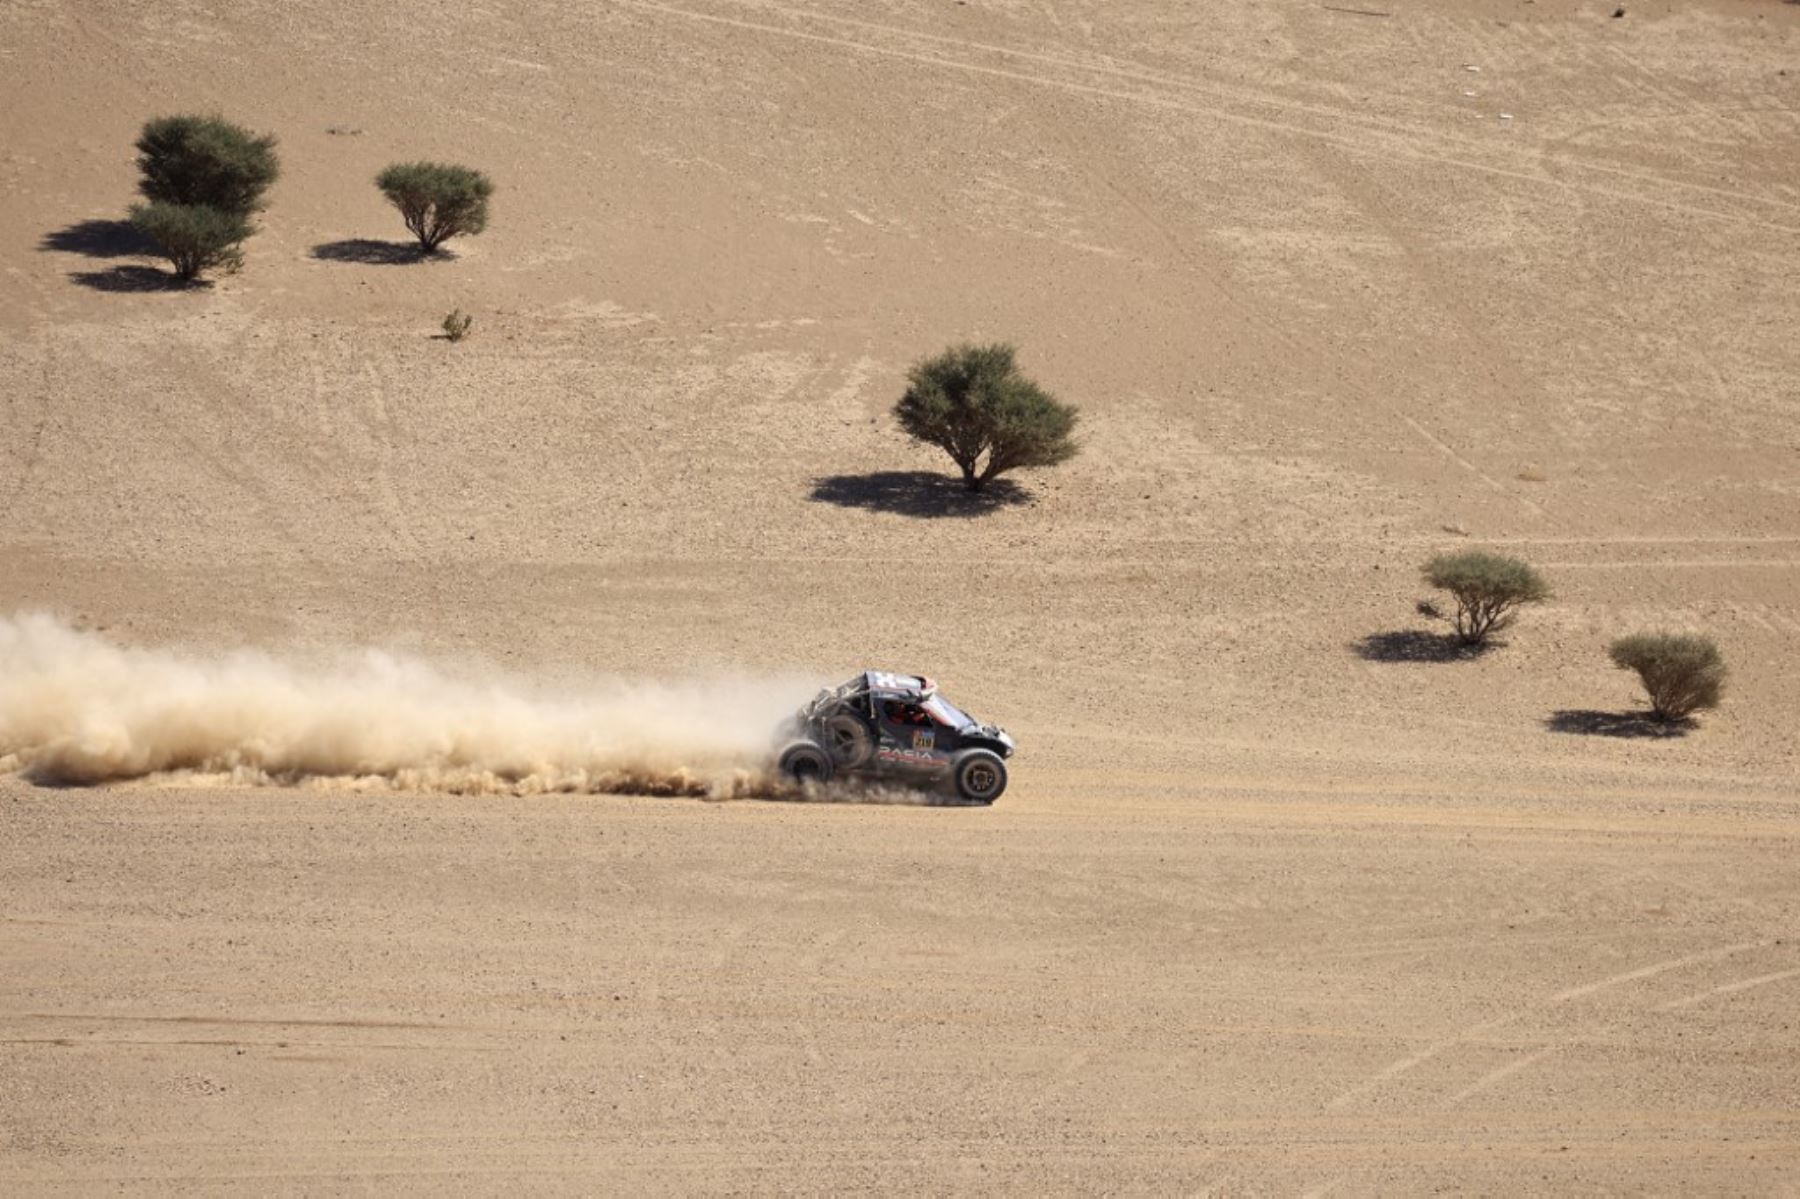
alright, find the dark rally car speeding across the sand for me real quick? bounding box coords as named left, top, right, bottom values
left=776, top=670, right=1015, bottom=803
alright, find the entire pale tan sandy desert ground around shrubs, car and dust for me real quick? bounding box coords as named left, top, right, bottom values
left=0, top=0, right=1800, bottom=1194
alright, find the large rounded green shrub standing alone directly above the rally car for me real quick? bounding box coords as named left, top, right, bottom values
left=895, top=344, right=1078, bottom=491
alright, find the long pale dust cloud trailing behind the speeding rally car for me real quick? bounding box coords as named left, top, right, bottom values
left=0, top=614, right=823, bottom=799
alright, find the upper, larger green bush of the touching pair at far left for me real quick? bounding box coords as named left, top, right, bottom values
left=137, top=117, right=281, bottom=216
